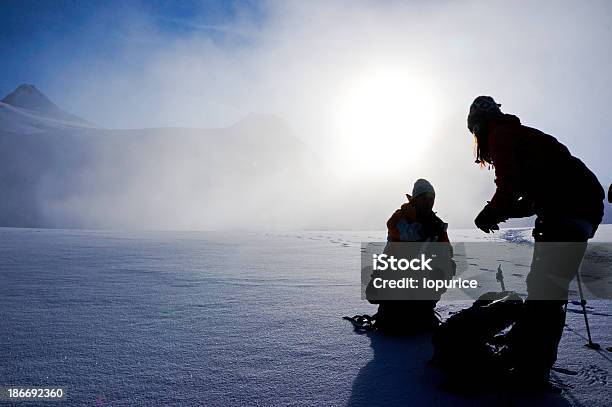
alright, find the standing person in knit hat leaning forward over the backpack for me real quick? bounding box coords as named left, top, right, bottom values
left=467, top=96, right=605, bottom=387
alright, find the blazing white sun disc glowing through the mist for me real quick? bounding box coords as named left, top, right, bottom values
left=335, top=70, right=434, bottom=174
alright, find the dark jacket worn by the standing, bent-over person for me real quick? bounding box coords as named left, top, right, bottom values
left=488, top=114, right=605, bottom=225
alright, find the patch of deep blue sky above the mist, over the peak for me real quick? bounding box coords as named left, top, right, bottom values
left=0, top=0, right=263, bottom=95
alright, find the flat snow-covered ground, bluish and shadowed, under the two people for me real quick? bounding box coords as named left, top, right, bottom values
left=0, top=226, right=612, bottom=406
